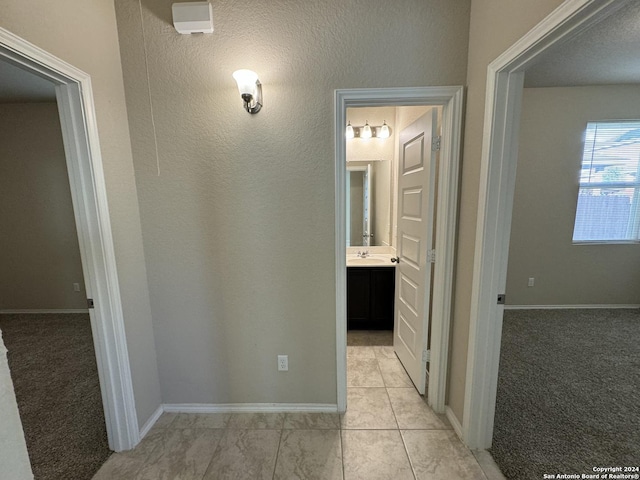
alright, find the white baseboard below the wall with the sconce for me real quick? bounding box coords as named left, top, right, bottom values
left=162, top=403, right=338, bottom=413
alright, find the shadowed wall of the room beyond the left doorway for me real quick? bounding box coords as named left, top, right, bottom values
left=0, top=102, right=87, bottom=310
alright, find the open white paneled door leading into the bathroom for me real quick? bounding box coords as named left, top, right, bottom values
left=393, top=108, right=437, bottom=395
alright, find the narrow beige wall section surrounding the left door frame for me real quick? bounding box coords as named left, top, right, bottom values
left=0, top=0, right=160, bottom=425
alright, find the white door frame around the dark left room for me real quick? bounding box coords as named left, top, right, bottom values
left=0, top=28, right=140, bottom=451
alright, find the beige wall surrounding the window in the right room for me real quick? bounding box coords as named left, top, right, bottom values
left=507, top=85, right=640, bottom=305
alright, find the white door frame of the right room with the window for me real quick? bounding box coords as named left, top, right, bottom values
left=462, top=0, right=631, bottom=449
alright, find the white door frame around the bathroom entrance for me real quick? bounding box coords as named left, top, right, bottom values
left=335, top=87, right=463, bottom=413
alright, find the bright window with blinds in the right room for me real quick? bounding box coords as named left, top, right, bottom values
left=573, top=120, right=640, bottom=243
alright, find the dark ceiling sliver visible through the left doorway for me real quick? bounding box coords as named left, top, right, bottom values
left=0, top=61, right=56, bottom=103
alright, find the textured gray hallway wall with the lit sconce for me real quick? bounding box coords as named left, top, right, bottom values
left=116, top=0, right=470, bottom=405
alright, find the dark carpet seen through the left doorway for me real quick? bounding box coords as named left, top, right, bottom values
left=0, top=314, right=111, bottom=480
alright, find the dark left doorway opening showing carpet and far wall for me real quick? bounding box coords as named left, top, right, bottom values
left=0, top=72, right=112, bottom=478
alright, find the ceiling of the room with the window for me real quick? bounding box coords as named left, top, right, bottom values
left=525, top=0, right=640, bottom=87
